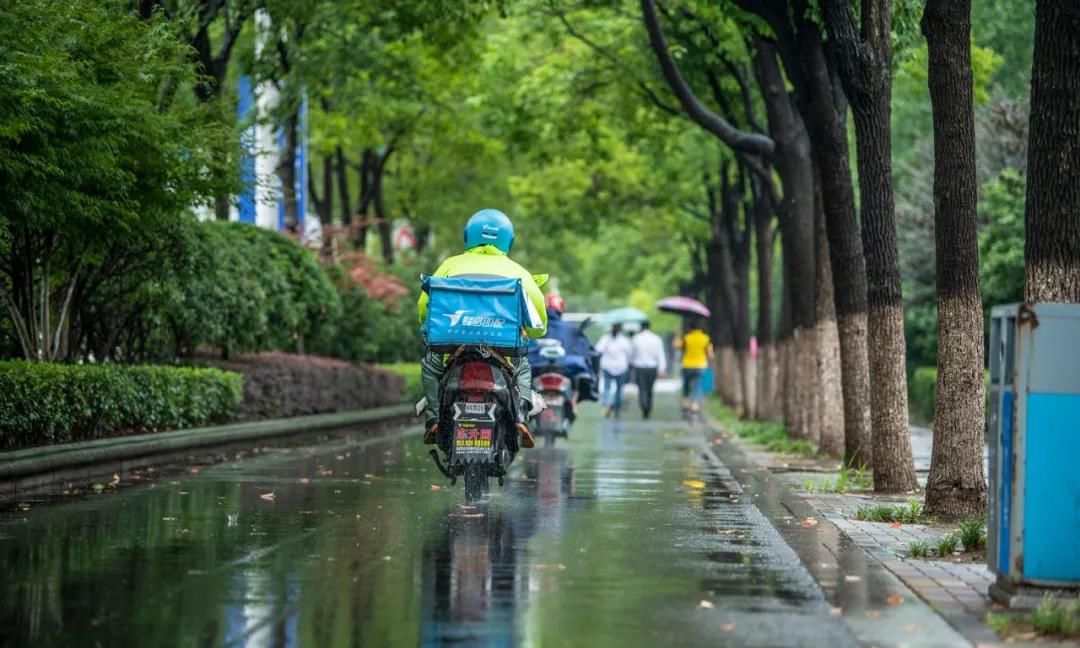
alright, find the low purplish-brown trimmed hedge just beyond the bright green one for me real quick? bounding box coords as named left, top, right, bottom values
left=214, top=352, right=405, bottom=420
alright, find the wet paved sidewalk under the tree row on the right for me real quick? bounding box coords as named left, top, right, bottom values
left=712, top=422, right=1017, bottom=646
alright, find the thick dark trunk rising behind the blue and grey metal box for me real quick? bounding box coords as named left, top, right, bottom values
left=1024, top=0, right=1080, bottom=303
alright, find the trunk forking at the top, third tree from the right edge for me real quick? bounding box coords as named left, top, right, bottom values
left=822, top=0, right=917, bottom=492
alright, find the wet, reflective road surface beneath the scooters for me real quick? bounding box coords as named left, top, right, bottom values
left=0, top=399, right=856, bottom=647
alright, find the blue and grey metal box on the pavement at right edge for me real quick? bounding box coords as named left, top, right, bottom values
left=987, top=303, right=1080, bottom=603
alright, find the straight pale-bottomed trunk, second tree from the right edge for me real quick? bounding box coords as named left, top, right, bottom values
left=922, top=0, right=986, bottom=518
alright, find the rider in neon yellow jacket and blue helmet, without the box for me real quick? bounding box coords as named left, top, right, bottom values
left=417, top=210, right=548, bottom=448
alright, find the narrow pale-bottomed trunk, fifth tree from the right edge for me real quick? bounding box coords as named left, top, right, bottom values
left=814, top=174, right=845, bottom=457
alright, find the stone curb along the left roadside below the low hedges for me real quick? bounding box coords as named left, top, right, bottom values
left=0, top=405, right=413, bottom=483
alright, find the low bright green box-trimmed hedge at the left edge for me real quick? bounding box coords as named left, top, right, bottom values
left=0, top=361, right=243, bottom=448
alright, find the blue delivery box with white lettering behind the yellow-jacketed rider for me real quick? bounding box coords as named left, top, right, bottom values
left=420, top=274, right=528, bottom=354
